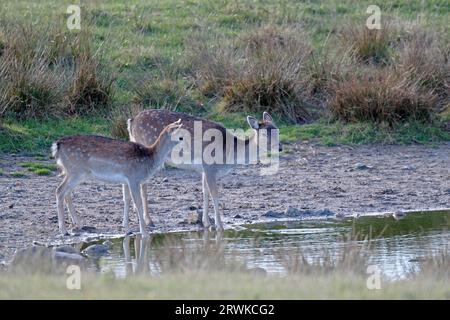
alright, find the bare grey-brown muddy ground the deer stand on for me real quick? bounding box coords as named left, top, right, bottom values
left=0, top=142, right=450, bottom=261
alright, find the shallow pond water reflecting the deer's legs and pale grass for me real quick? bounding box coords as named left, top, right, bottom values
left=84, top=211, right=450, bottom=279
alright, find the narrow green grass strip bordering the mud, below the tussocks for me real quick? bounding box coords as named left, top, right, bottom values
left=0, top=115, right=450, bottom=156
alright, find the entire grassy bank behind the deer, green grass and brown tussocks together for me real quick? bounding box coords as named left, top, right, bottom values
left=0, top=0, right=450, bottom=153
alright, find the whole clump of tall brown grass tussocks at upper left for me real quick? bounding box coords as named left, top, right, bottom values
left=0, top=25, right=113, bottom=119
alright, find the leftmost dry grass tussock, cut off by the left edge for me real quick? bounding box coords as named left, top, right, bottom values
left=0, top=27, right=62, bottom=118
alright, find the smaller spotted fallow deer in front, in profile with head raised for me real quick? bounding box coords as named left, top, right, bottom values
left=52, top=119, right=182, bottom=236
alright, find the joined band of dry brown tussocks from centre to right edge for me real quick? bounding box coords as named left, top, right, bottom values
left=188, top=24, right=450, bottom=125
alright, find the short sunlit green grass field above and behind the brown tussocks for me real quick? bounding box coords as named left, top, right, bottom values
left=0, top=0, right=450, bottom=103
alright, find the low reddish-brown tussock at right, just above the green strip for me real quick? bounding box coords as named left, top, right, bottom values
left=329, top=69, right=436, bottom=125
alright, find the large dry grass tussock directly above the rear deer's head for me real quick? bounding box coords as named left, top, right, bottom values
left=188, top=26, right=320, bottom=122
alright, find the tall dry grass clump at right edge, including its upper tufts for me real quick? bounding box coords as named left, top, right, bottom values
left=328, top=23, right=450, bottom=126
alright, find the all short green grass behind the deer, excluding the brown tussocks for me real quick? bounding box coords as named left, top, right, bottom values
left=0, top=0, right=450, bottom=154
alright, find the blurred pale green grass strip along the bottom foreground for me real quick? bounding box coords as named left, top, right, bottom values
left=0, top=272, right=450, bottom=299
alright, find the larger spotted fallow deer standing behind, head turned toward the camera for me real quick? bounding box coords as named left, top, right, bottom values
left=128, top=109, right=281, bottom=230
